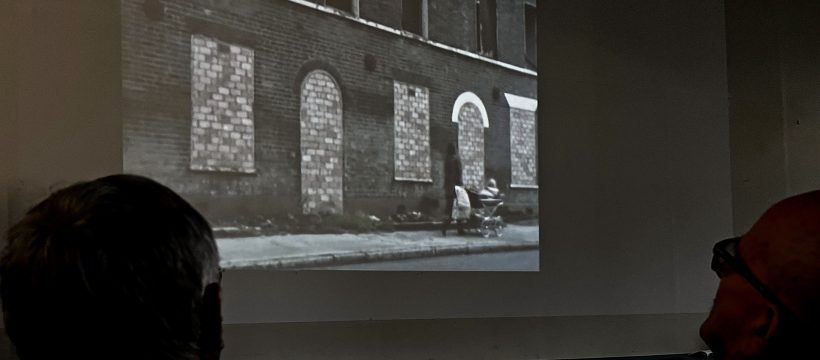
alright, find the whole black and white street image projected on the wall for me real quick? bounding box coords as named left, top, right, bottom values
left=122, top=0, right=539, bottom=271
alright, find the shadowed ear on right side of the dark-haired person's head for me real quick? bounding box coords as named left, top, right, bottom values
left=198, top=283, right=225, bottom=360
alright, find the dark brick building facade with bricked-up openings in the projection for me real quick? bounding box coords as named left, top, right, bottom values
left=121, top=0, right=538, bottom=220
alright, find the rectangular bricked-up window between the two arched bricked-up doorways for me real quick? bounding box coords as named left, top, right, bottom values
left=393, top=81, right=432, bottom=182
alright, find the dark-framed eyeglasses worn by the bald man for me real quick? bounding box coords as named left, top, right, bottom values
left=712, top=237, right=791, bottom=314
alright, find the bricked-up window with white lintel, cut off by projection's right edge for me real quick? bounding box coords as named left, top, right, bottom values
left=505, top=94, right=538, bottom=188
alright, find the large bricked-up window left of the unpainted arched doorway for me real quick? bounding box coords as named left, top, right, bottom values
left=190, top=35, right=255, bottom=173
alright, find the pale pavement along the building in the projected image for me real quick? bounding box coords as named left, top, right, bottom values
left=217, top=224, right=538, bottom=270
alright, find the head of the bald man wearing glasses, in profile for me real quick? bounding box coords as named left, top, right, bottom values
left=700, top=191, right=820, bottom=360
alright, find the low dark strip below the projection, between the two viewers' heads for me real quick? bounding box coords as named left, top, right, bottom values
left=223, top=314, right=702, bottom=360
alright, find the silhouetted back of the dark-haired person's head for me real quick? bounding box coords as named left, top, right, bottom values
left=0, top=175, right=221, bottom=360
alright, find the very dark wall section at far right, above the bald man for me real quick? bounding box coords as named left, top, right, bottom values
left=726, top=0, right=820, bottom=233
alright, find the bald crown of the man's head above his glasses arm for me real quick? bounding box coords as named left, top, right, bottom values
left=740, top=191, right=820, bottom=323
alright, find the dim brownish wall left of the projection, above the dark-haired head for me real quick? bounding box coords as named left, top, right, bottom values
left=3, top=0, right=122, bottom=225
